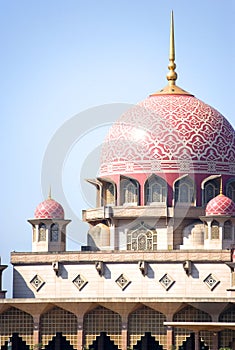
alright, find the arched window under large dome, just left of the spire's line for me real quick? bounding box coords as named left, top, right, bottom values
left=145, top=175, right=167, bottom=204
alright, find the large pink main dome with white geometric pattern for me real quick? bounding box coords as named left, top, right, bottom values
left=100, top=95, right=235, bottom=176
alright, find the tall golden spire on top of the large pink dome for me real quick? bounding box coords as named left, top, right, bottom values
left=150, top=11, right=193, bottom=96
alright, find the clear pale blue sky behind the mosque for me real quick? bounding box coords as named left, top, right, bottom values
left=0, top=0, right=235, bottom=296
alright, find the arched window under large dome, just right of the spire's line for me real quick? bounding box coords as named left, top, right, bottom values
left=175, top=176, right=195, bottom=204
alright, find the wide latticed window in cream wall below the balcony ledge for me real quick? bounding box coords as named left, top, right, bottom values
left=127, top=225, right=157, bottom=250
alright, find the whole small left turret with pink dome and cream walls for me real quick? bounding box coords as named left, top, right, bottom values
left=28, top=189, right=71, bottom=252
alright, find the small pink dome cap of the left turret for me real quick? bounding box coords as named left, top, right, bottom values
left=34, top=198, right=64, bottom=219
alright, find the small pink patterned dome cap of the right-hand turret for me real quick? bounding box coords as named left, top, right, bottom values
left=206, top=194, right=235, bottom=216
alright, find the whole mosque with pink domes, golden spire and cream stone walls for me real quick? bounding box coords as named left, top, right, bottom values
left=0, top=10, right=235, bottom=350
